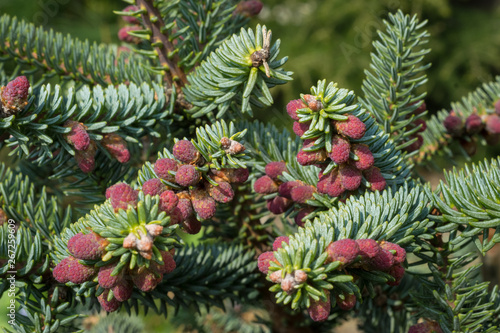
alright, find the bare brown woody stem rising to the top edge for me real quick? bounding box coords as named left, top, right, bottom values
left=137, top=0, right=187, bottom=92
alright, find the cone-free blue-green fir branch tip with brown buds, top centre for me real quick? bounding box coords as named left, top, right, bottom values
left=183, top=25, right=292, bottom=118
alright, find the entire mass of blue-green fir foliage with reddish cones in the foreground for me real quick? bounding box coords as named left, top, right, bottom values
left=0, top=0, right=500, bottom=333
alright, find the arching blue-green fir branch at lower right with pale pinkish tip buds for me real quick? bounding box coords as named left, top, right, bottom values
left=262, top=185, right=433, bottom=319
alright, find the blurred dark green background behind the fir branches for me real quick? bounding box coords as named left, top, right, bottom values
left=0, top=0, right=500, bottom=332
